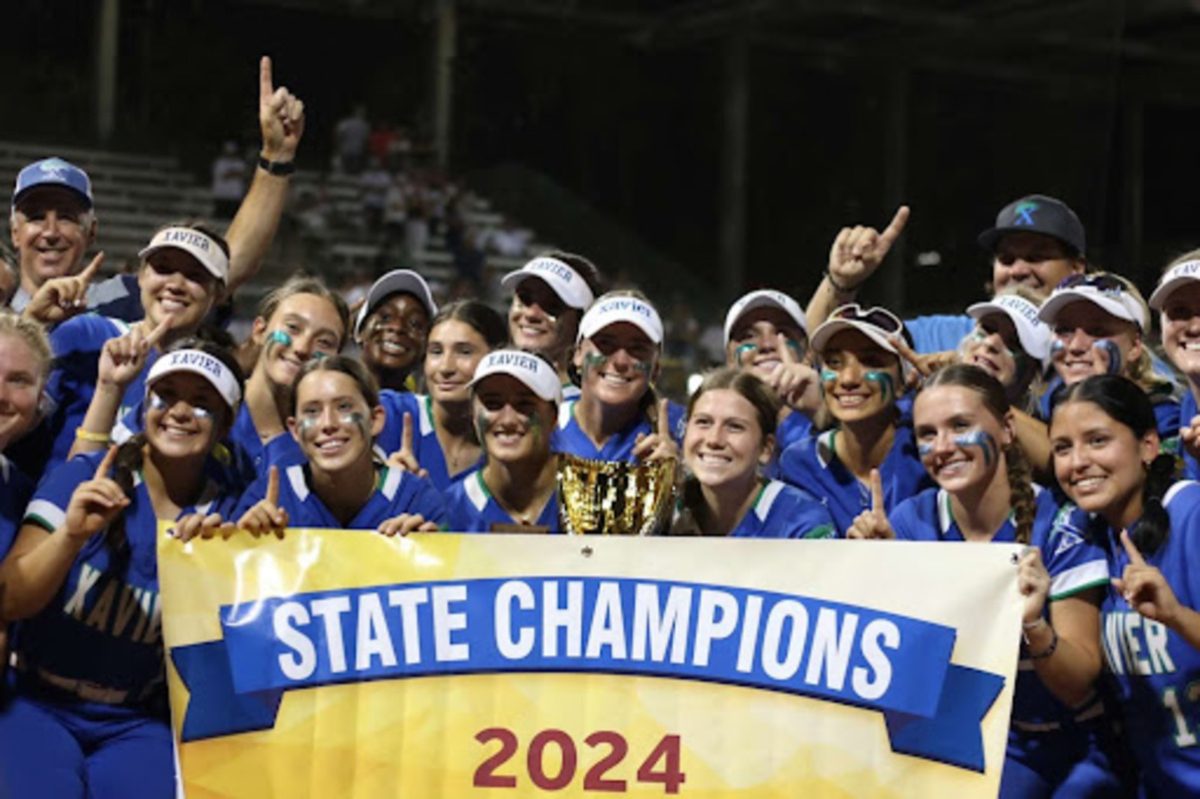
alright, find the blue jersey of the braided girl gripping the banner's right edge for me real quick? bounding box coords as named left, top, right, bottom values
left=888, top=486, right=1109, bottom=726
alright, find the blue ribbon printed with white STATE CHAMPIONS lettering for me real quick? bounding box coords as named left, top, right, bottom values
left=170, top=577, right=1004, bottom=771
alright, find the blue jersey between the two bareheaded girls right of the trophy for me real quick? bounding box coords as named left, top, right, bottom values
left=779, top=426, right=934, bottom=537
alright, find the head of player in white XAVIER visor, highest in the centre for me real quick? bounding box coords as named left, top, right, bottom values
left=500, top=252, right=600, bottom=398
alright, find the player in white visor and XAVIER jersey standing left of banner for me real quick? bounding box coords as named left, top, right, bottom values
left=0, top=340, right=241, bottom=799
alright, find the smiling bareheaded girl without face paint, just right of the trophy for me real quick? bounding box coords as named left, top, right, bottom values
left=670, top=367, right=834, bottom=539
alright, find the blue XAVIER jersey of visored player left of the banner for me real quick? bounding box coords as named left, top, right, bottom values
left=13, top=452, right=235, bottom=704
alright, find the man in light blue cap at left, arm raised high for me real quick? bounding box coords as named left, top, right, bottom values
left=10, top=56, right=304, bottom=323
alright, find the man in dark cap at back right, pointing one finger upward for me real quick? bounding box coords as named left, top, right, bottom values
left=808, top=194, right=1087, bottom=353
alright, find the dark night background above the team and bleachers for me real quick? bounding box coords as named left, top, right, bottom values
left=0, top=0, right=1200, bottom=312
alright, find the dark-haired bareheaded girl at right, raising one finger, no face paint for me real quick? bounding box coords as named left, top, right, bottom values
left=1050, top=376, right=1200, bottom=797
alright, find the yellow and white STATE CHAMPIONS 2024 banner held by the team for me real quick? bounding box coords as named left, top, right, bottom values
left=158, top=530, right=1021, bottom=799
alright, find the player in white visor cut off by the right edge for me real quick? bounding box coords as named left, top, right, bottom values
left=1150, top=255, right=1200, bottom=480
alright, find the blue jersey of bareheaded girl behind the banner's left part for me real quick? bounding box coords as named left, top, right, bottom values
left=233, top=463, right=445, bottom=530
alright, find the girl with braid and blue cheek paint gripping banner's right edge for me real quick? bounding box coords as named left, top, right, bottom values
left=847, top=365, right=1120, bottom=799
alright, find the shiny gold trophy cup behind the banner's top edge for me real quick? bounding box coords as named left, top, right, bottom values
left=558, top=453, right=676, bottom=535
